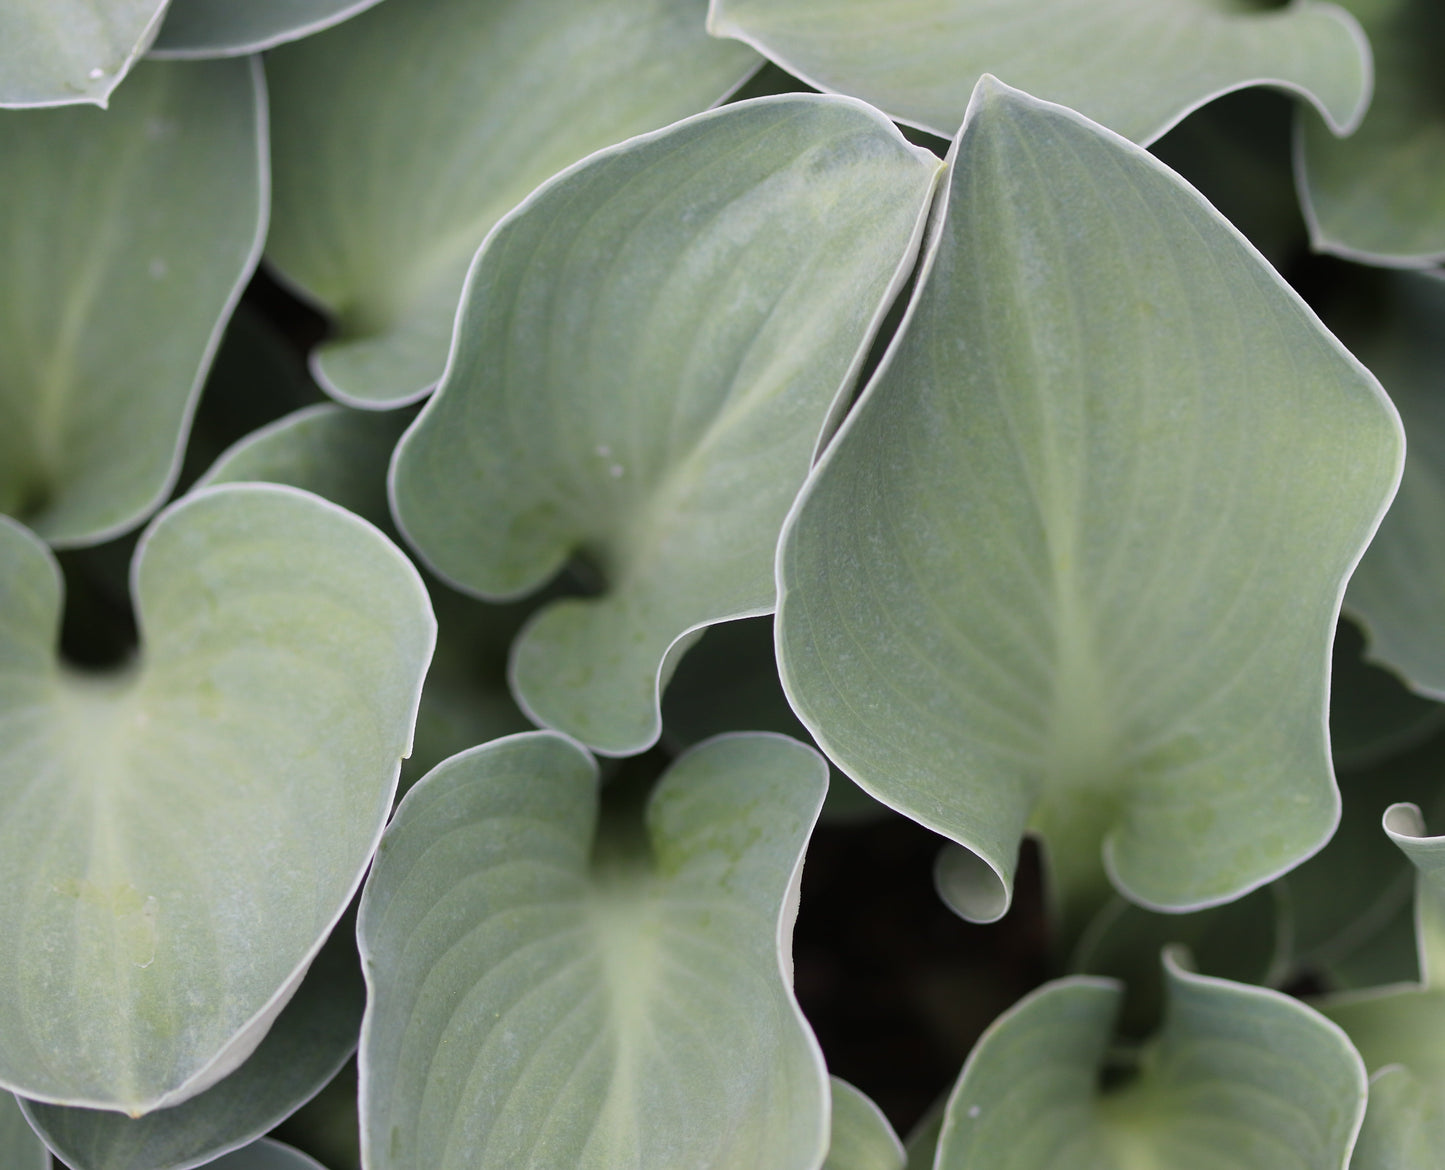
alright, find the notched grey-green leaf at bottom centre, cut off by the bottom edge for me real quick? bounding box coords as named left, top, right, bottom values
left=360, top=732, right=828, bottom=1170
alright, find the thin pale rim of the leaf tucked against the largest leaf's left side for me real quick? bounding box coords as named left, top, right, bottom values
left=390, top=91, right=952, bottom=751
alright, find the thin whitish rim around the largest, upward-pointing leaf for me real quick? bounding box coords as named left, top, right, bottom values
left=773, top=74, right=1405, bottom=923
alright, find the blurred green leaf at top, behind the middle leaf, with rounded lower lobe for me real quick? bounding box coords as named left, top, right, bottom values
left=266, top=0, right=757, bottom=406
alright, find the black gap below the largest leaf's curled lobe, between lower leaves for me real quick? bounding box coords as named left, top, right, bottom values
left=793, top=813, right=1051, bottom=1132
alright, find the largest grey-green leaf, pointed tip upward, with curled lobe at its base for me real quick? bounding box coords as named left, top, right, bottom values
left=777, top=78, right=1402, bottom=922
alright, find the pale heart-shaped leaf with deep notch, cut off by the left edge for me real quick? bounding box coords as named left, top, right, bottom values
left=0, top=484, right=435, bottom=1115
